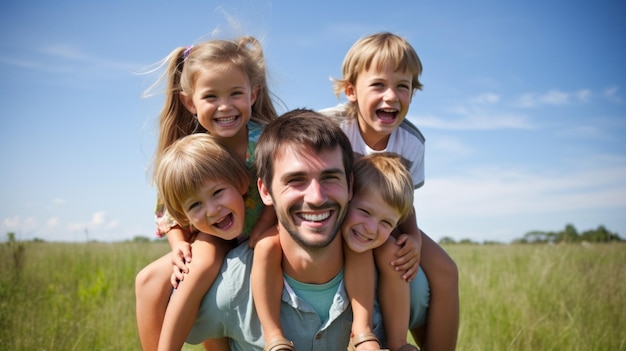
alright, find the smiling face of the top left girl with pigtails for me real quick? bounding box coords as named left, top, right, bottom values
left=181, top=67, right=257, bottom=138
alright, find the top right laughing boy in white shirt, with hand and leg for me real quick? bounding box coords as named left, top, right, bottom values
left=322, top=33, right=459, bottom=350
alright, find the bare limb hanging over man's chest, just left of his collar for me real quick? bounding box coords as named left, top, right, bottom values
left=250, top=231, right=285, bottom=345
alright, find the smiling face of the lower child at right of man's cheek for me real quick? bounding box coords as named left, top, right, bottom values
left=341, top=191, right=400, bottom=253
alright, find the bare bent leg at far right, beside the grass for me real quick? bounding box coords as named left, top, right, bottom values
left=411, top=232, right=459, bottom=350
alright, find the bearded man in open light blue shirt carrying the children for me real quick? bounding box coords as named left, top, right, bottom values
left=187, top=110, right=428, bottom=351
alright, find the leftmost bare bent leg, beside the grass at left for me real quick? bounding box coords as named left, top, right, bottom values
left=135, top=253, right=172, bottom=351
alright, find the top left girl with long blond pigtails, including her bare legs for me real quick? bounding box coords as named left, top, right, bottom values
left=136, top=37, right=276, bottom=350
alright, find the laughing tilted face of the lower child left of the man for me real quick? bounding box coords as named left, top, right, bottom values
left=183, top=179, right=245, bottom=240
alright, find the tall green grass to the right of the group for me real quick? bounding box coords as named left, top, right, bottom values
left=446, top=244, right=626, bottom=350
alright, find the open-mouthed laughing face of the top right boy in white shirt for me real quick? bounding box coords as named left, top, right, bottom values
left=345, top=64, right=413, bottom=150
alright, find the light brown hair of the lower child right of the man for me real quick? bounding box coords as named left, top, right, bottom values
left=352, top=152, right=414, bottom=222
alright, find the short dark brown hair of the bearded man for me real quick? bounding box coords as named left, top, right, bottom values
left=254, top=109, right=354, bottom=189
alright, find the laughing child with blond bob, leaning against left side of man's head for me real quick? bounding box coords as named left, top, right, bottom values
left=154, top=133, right=250, bottom=350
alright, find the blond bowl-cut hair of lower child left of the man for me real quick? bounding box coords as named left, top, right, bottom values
left=154, top=133, right=250, bottom=226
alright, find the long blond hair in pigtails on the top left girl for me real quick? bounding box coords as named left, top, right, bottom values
left=148, top=37, right=276, bottom=166
